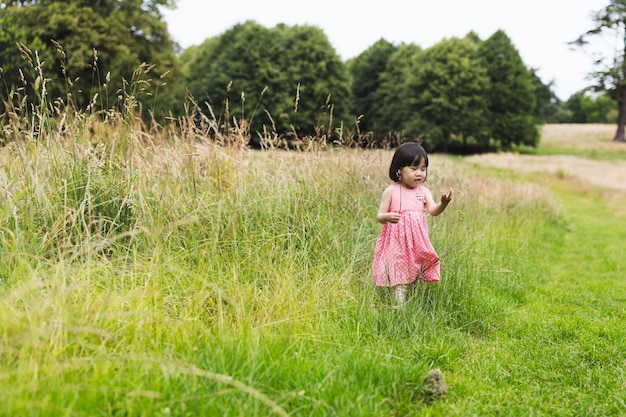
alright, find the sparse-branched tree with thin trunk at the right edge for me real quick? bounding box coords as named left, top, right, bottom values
left=571, top=0, right=626, bottom=142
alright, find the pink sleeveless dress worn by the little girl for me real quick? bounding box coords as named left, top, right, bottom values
left=372, top=183, right=439, bottom=286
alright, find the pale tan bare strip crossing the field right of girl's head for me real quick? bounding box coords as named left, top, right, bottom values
left=466, top=153, right=626, bottom=191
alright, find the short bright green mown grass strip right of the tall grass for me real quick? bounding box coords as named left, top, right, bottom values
left=444, top=180, right=626, bottom=416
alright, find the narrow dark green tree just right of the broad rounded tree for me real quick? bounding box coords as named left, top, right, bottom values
left=348, top=39, right=397, bottom=137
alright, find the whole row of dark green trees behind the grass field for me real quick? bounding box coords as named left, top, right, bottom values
left=0, top=0, right=615, bottom=152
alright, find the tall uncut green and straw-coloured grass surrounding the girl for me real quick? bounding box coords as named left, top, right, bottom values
left=0, top=53, right=572, bottom=416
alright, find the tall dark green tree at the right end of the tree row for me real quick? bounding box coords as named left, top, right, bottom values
left=478, top=30, right=539, bottom=149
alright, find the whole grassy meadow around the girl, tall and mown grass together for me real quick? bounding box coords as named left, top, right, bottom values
left=0, top=109, right=626, bottom=417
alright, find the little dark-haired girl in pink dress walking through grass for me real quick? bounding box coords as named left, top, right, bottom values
left=372, top=142, right=452, bottom=305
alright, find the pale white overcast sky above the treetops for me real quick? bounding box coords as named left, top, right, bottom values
left=163, top=0, right=608, bottom=100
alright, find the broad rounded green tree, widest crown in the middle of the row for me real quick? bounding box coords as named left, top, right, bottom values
left=181, top=21, right=350, bottom=144
